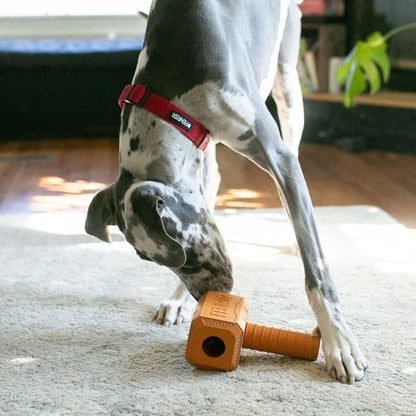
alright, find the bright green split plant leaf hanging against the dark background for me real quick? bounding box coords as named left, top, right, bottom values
left=337, top=32, right=390, bottom=107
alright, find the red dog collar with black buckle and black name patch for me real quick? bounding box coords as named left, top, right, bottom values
left=118, top=84, right=211, bottom=150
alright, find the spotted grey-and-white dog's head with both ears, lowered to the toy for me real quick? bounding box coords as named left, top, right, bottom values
left=85, top=170, right=232, bottom=298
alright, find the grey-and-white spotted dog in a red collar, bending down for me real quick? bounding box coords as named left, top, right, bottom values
left=85, top=0, right=367, bottom=384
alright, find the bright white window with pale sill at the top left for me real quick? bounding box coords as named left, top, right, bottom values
left=0, top=0, right=151, bottom=39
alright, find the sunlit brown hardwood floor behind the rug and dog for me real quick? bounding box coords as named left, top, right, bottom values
left=0, top=139, right=416, bottom=228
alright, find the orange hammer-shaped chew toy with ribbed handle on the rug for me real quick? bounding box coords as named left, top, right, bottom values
left=185, top=292, right=320, bottom=371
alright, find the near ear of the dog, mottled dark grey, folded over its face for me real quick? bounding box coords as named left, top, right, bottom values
left=131, top=189, right=186, bottom=268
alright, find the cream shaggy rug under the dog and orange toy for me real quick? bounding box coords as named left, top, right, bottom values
left=0, top=206, right=416, bottom=416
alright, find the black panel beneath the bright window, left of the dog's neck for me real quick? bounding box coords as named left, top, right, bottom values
left=0, top=51, right=138, bottom=140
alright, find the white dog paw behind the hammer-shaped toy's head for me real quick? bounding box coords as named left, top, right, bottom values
left=153, top=288, right=197, bottom=326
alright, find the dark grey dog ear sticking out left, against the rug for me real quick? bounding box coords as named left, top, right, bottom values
left=85, top=184, right=117, bottom=243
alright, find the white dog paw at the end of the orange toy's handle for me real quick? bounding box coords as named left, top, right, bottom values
left=321, top=324, right=368, bottom=384
